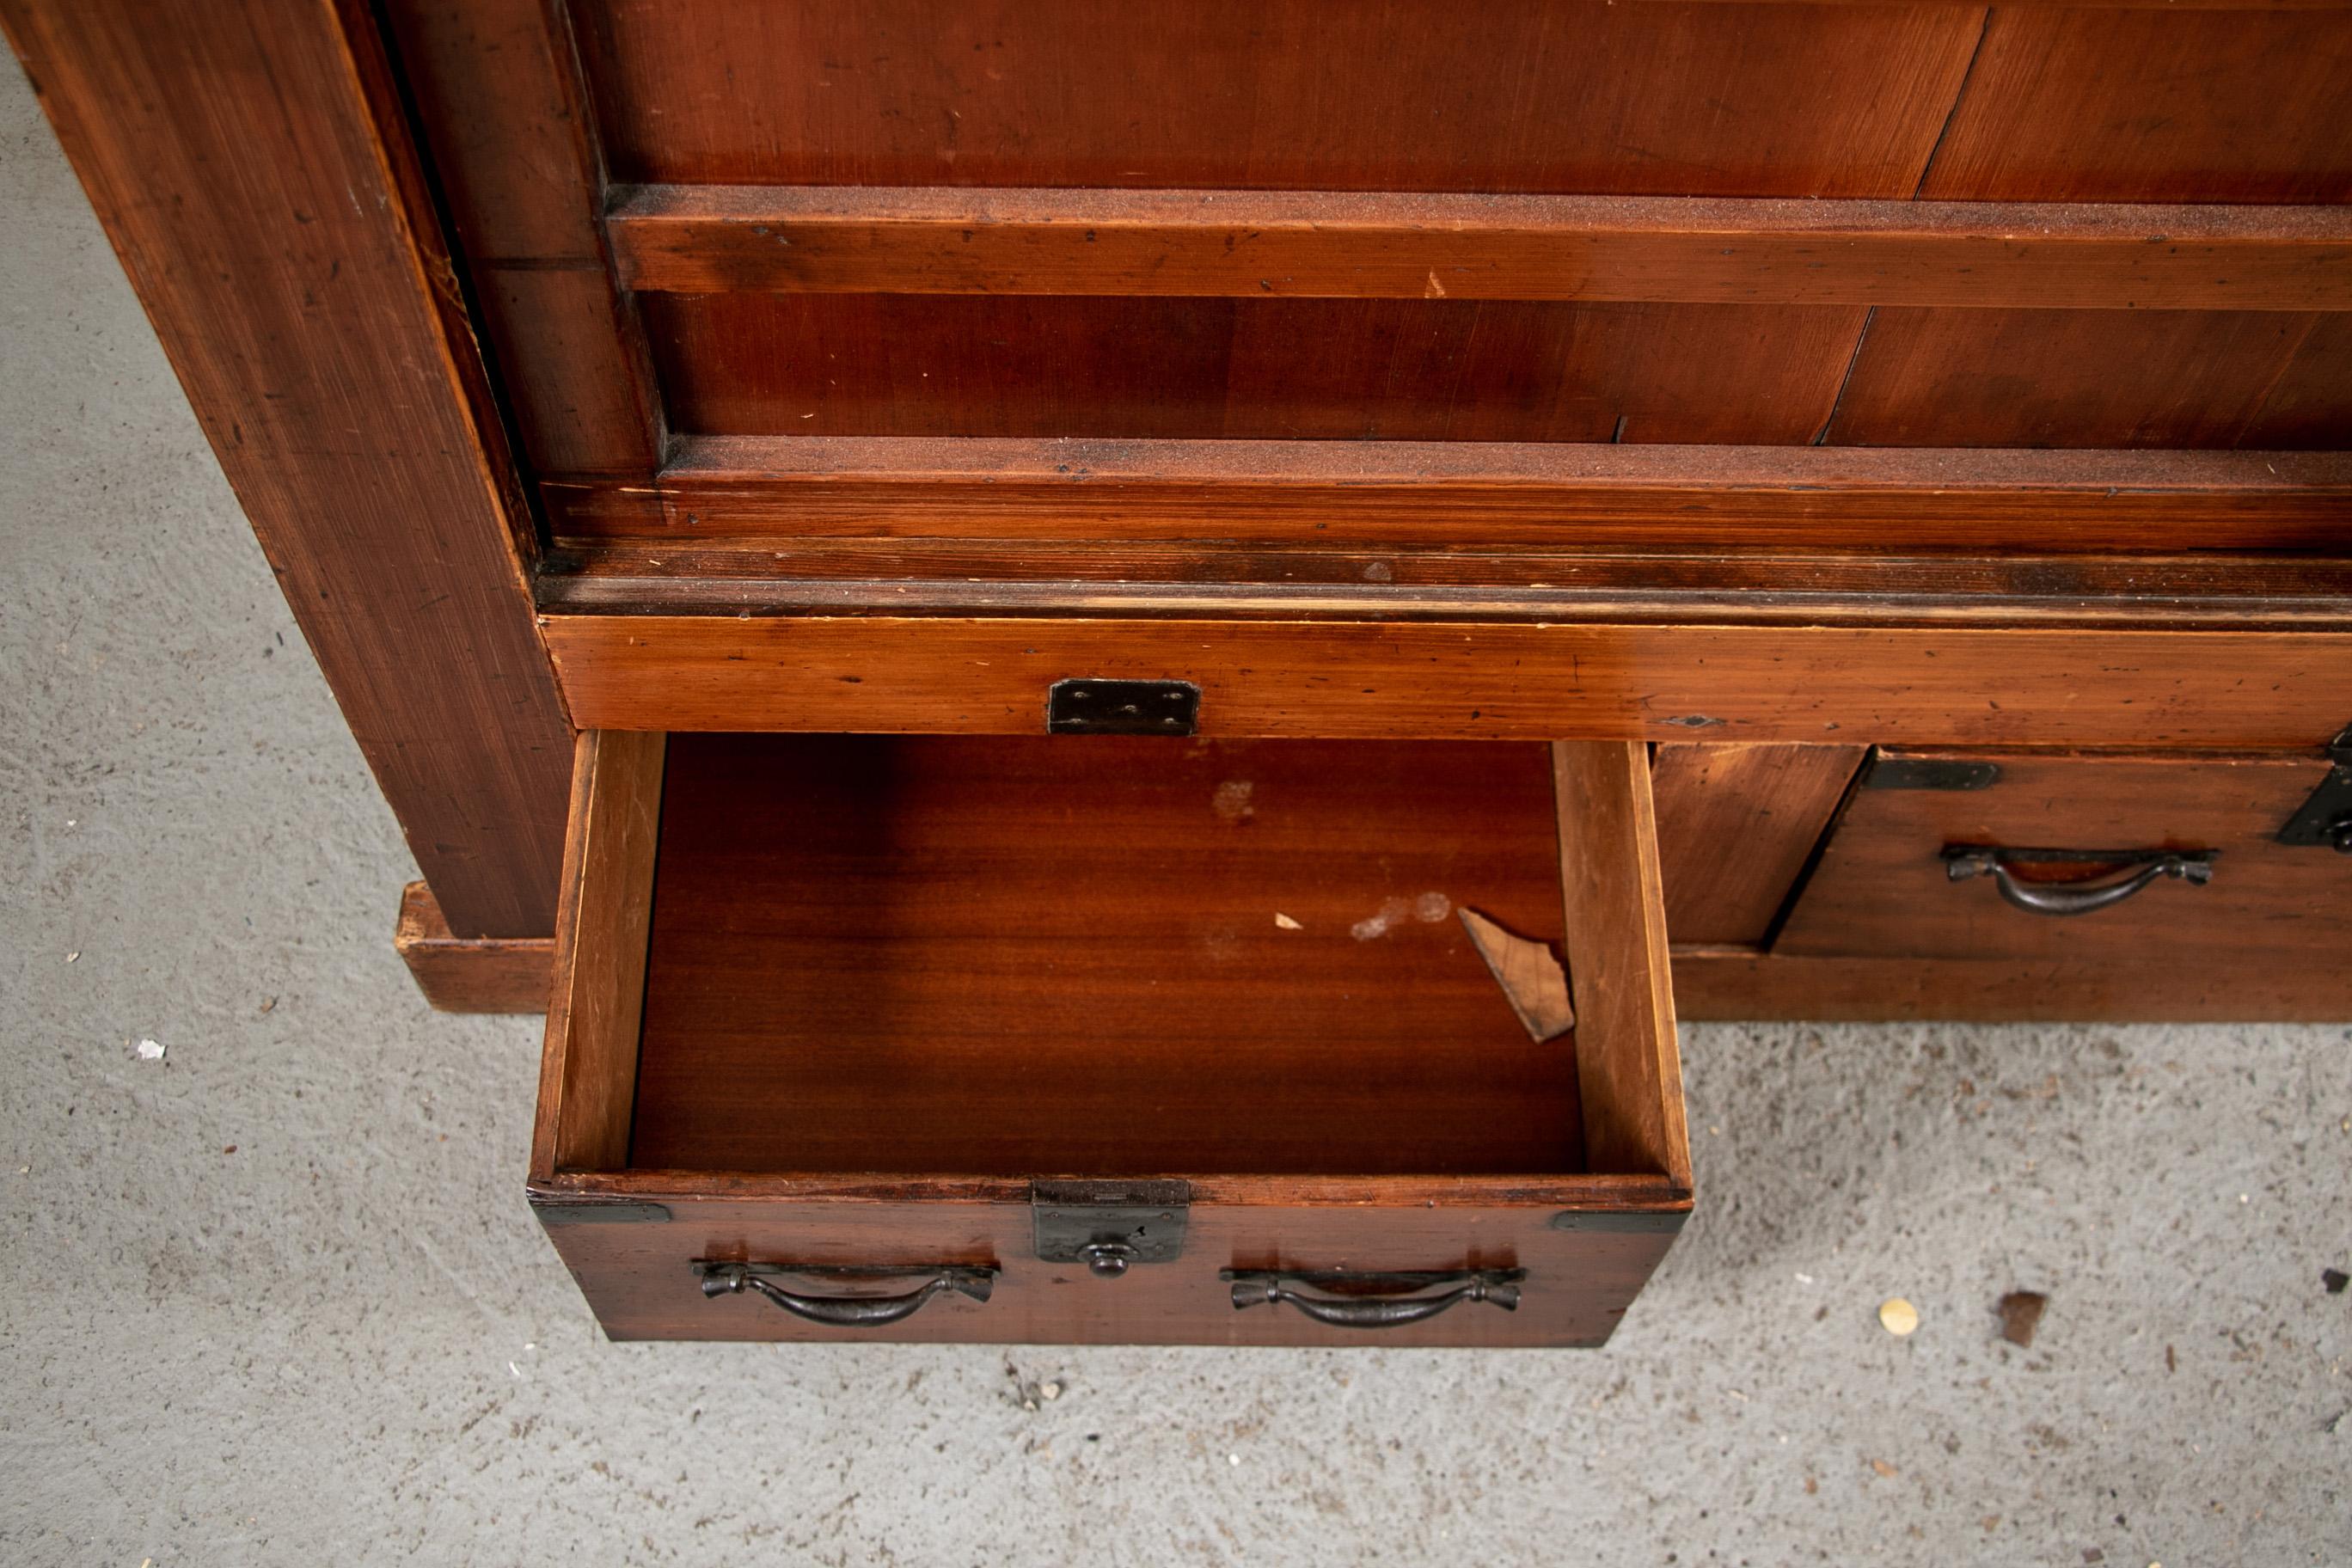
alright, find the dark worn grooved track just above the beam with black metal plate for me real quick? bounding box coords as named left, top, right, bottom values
left=539, top=541, right=2352, bottom=630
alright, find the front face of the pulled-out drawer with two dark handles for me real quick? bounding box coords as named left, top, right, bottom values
left=541, top=1194, right=1681, bottom=1347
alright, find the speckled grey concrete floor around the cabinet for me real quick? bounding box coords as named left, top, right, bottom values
left=0, top=52, right=2352, bottom=1568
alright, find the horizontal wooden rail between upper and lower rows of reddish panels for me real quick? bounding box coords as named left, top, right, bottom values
left=609, top=186, right=2352, bottom=310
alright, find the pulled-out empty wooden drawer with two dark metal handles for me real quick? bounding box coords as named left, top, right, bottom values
left=530, top=731, right=1691, bottom=1344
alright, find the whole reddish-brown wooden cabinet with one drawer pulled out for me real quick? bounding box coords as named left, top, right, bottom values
left=0, top=0, right=2352, bottom=1342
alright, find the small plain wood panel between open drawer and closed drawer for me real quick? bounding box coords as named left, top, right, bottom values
left=1651, top=745, right=1863, bottom=945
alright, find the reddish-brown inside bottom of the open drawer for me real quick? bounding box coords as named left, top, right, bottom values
left=630, top=738, right=1580, bottom=1175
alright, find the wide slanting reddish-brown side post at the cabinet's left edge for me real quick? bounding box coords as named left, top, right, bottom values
left=0, top=0, right=572, bottom=935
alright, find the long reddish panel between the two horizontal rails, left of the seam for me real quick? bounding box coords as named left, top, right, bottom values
left=645, top=294, right=1863, bottom=444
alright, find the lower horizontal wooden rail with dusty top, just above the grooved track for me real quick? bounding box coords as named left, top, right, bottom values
left=543, top=438, right=2352, bottom=554
